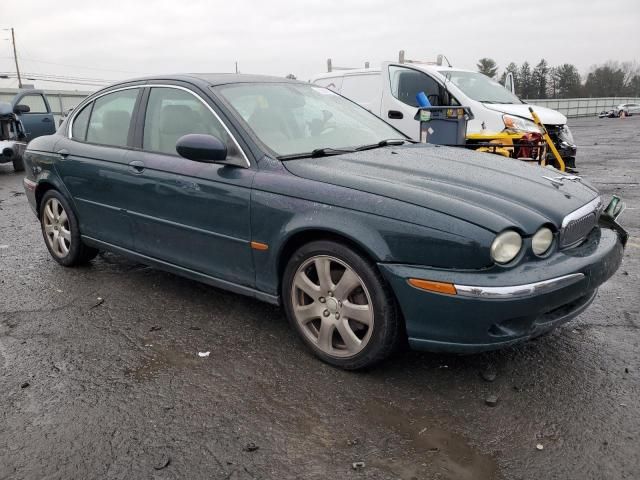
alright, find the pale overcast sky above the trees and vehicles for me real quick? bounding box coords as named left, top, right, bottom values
left=0, top=0, right=640, bottom=90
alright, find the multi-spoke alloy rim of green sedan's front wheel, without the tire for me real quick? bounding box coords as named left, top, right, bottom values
left=291, top=255, right=374, bottom=358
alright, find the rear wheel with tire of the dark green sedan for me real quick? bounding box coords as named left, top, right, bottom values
left=40, top=190, right=98, bottom=267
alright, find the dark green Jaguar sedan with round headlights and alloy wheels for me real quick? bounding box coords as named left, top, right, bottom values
left=24, top=74, right=626, bottom=369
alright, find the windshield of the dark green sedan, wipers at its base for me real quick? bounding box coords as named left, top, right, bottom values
left=214, top=83, right=405, bottom=156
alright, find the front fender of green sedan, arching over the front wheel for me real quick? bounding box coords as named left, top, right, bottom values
left=251, top=190, right=493, bottom=295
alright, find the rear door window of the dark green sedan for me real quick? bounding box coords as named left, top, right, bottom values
left=87, top=88, right=140, bottom=147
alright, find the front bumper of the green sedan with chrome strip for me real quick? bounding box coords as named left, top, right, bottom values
left=379, top=228, right=623, bottom=353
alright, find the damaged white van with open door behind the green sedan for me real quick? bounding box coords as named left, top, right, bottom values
left=311, top=62, right=576, bottom=168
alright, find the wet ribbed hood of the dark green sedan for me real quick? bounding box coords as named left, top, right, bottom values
left=283, top=144, right=598, bottom=234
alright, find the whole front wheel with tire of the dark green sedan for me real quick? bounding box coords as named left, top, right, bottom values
left=282, top=240, right=404, bottom=370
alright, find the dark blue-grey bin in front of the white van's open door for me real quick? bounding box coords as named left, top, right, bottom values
left=414, top=105, right=473, bottom=145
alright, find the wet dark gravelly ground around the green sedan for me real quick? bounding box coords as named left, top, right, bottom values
left=0, top=117, right=640, bottom=480
